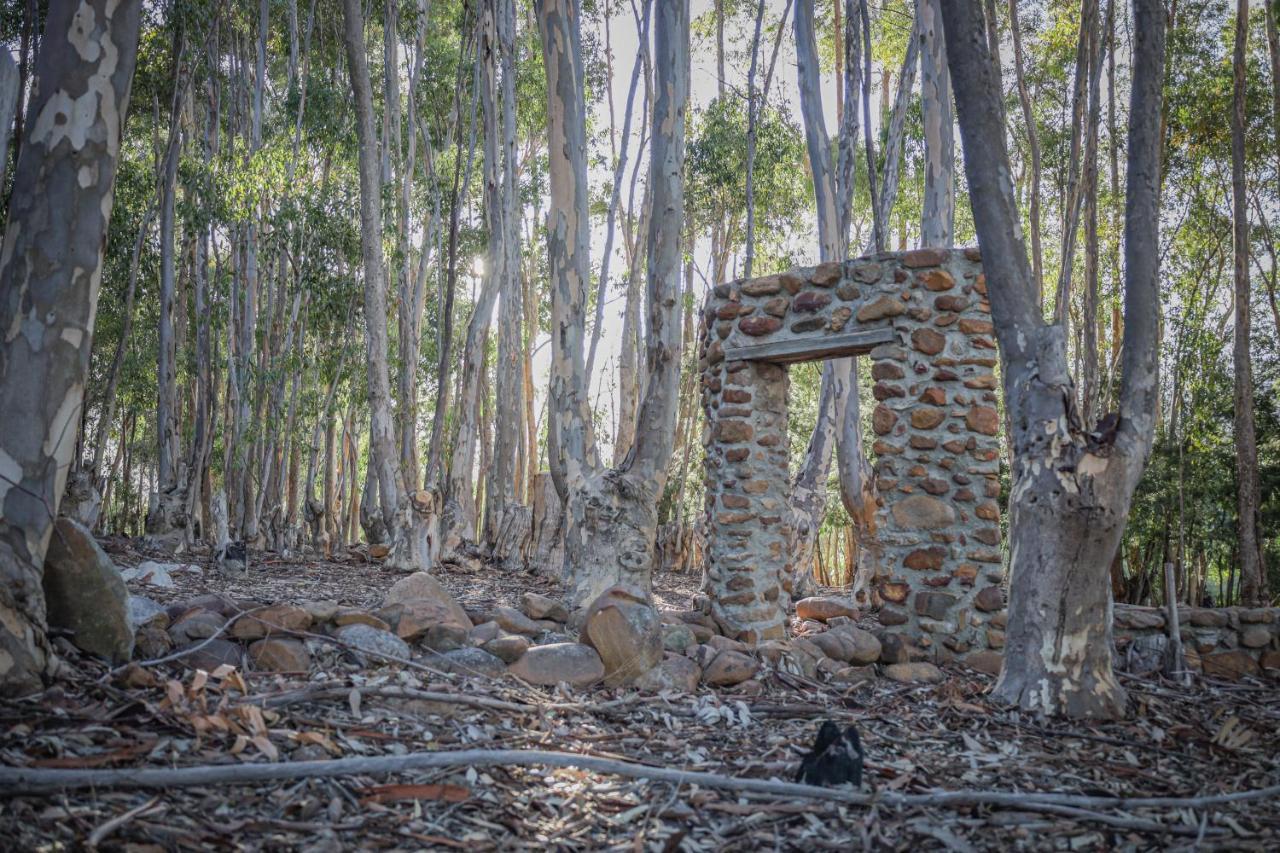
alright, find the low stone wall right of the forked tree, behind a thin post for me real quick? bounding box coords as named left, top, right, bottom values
left=1114, top=605, right=1280, bottom=680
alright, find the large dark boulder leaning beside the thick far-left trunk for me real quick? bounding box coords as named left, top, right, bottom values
left=44, top=519, right=133, bottom=663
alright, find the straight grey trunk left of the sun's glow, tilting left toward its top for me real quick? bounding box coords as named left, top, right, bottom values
left=343, top=0, right=404, bottom=545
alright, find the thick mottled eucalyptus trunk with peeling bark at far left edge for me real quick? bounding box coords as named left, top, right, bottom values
left=0, top=0, right=141, bottom=695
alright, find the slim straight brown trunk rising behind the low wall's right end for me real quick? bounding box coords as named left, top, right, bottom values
left=1231, top=0, right=1266, bottom=605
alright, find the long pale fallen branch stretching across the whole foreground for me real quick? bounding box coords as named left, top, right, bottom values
left=0, top=749, right=1264, bottom=833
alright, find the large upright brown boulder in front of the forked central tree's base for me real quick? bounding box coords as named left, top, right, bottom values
left=581, top=584, right=663, bottom=686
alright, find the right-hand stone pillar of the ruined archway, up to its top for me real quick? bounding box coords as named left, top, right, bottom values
left=870, top=250, right=1004, bottom=660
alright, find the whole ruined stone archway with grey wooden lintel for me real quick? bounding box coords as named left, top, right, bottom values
left=699, top=248, right=1004, bottom=658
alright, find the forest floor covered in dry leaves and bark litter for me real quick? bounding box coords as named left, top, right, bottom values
left=0, top=540, right=1280, bottom=852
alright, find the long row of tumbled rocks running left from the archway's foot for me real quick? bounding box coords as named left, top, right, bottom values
left=115, top=573, right=957, bottom=694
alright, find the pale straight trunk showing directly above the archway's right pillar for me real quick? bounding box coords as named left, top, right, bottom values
left=915, top=0, right=956, bottom=248
